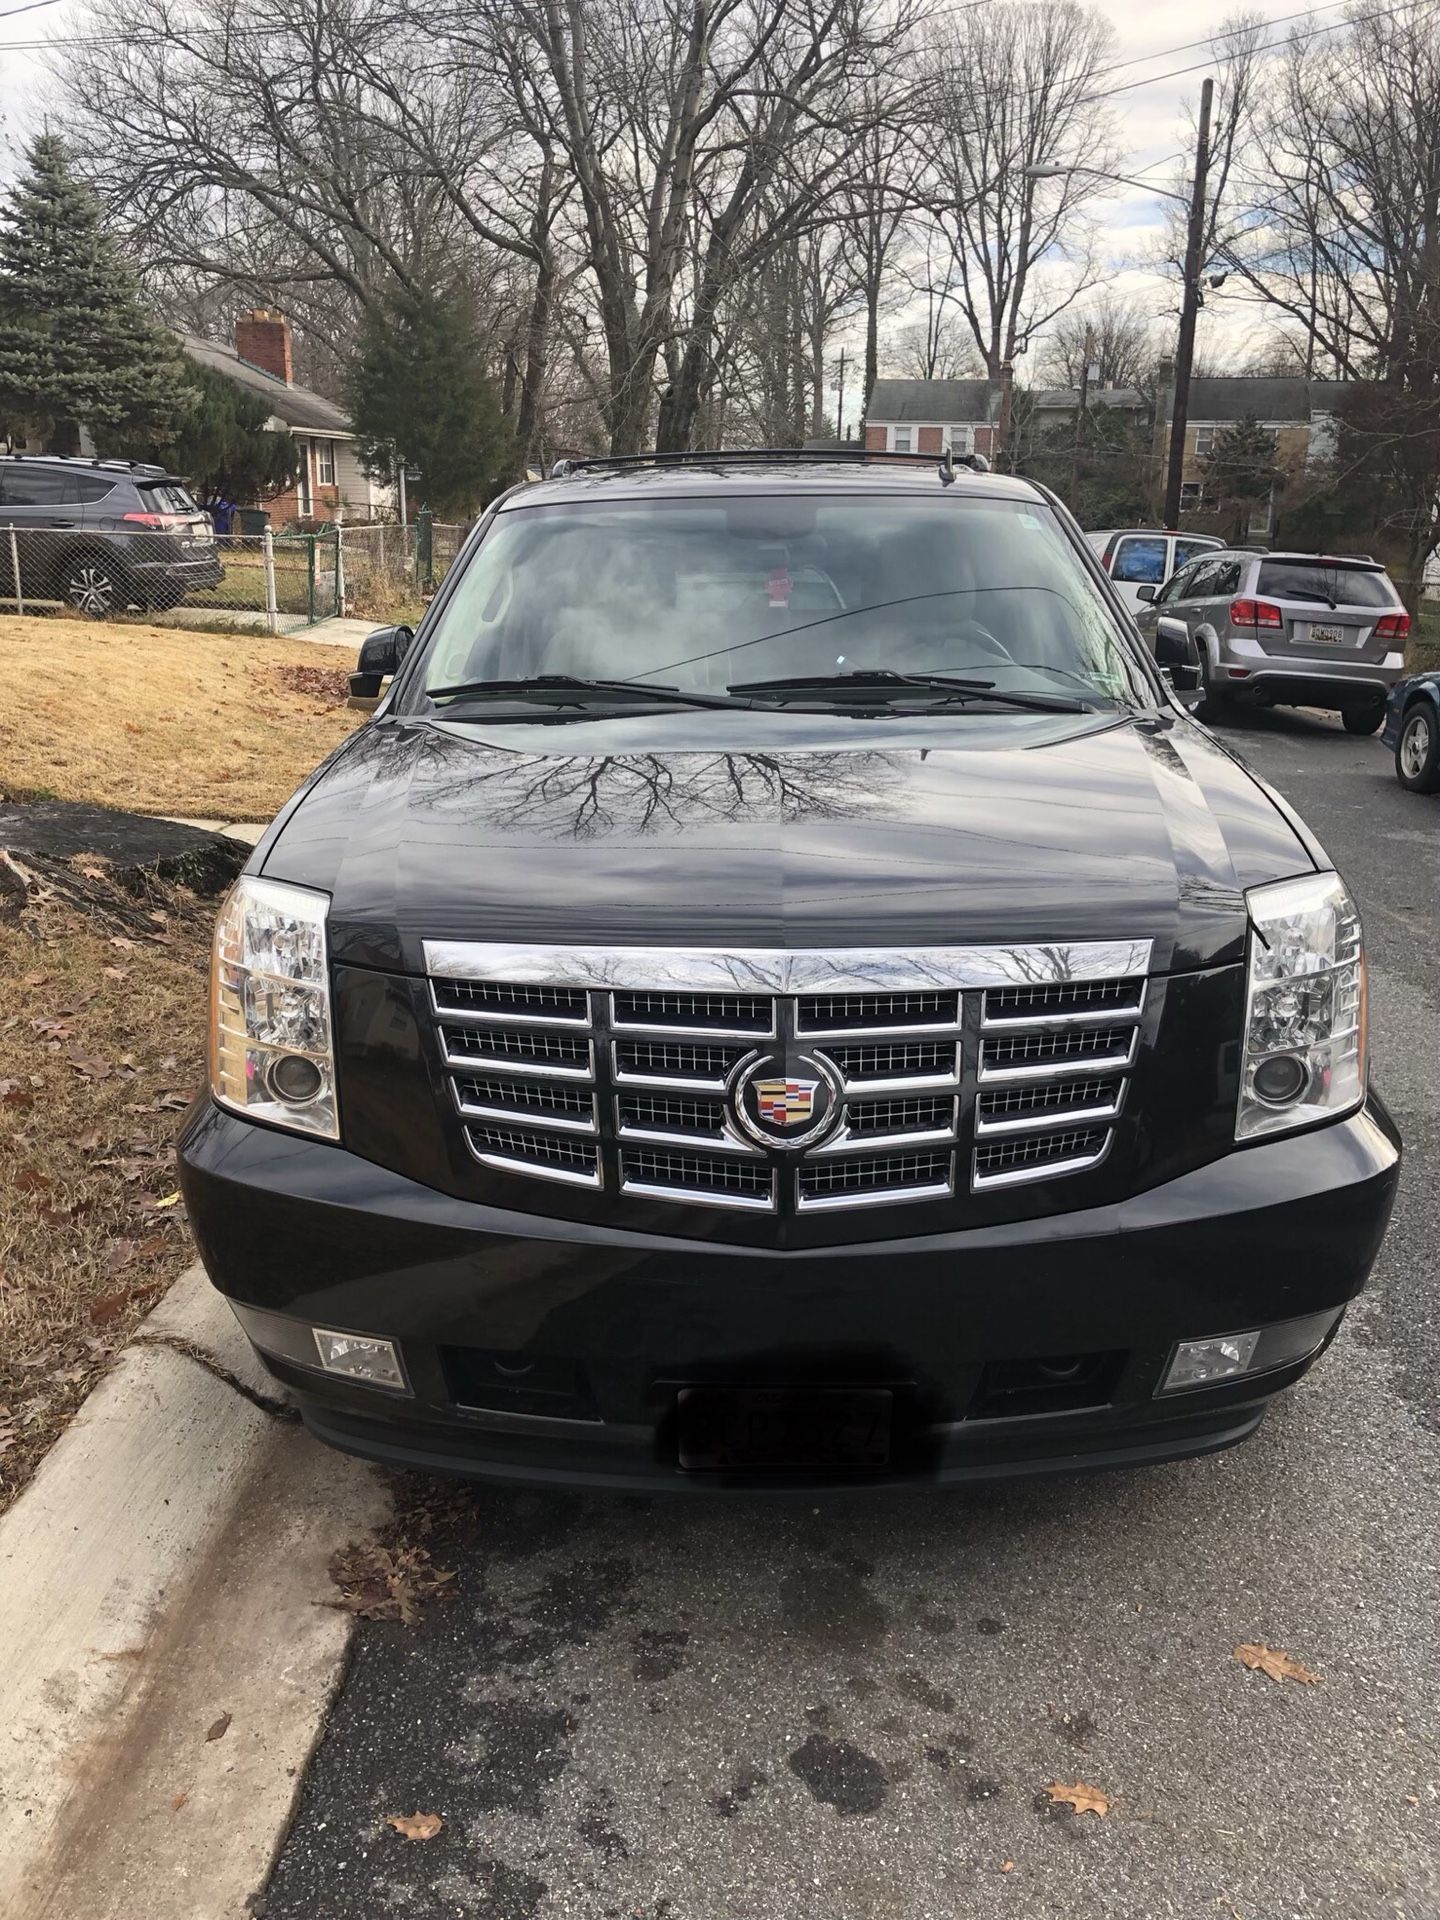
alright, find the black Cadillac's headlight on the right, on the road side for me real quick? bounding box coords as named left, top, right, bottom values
left=1235, top=874, right=1365, bottom=1140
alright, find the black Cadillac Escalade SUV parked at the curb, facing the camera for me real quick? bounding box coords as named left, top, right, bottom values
left=180, top=455, right=1400, bottom=1488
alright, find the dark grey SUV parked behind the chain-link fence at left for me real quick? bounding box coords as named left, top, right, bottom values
left=0, top=453, right=225, bottom=616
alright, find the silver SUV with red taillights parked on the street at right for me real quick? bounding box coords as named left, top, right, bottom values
left=1135, top=547, right=1409, bottom=733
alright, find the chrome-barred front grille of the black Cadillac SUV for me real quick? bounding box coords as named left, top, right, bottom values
left=426, top=943, right=1150, bottom=1213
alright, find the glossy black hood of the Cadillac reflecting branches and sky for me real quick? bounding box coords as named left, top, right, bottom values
left=259, top=712, right=1315, bottom=972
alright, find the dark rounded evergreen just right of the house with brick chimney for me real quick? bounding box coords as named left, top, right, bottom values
left=348, top=290, right=515, bottom=516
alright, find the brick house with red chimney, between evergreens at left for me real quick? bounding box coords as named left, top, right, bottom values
left=180, top=307, right=396, bottom=526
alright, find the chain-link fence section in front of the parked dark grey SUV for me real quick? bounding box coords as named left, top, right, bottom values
left=0, top=524, right=340, bottom=632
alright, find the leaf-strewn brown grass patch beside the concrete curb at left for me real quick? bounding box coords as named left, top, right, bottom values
left=0, top=871, right=215, bottom=1509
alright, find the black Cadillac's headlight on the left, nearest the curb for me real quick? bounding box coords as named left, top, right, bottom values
left=209, top=876, right=340, bottom=1140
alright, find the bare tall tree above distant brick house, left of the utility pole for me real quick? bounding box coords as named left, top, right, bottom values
left=925, top=0, right=1116, bottom=378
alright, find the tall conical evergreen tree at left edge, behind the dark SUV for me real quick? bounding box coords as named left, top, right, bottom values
left=0, top=134, right=192, bottom=453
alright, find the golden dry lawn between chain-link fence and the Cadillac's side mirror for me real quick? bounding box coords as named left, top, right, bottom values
left=0, top=616, right=357, bottom=820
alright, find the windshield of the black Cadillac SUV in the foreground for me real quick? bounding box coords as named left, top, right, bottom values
left=410, top=493, right=1152, bottom=707
